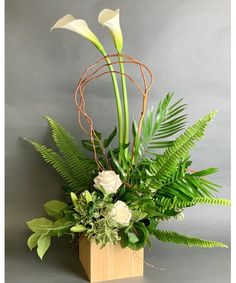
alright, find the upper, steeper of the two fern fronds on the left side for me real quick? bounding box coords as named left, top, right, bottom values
left=45, top=117, right=96, bottom=191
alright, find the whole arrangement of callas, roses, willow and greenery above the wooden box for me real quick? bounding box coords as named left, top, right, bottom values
left=26, top=9, right=230, bottom=259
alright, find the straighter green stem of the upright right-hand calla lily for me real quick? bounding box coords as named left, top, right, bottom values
left=119, top=56, right=129, bottom=158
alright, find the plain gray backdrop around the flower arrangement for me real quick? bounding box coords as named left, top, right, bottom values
left=6, top=0, right=230, bottom=283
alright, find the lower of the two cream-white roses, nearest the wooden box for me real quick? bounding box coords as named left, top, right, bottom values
left=108, top=200, right=132, bottom=226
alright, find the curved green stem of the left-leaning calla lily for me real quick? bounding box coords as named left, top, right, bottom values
left=103, top=52, right=124, bottom=161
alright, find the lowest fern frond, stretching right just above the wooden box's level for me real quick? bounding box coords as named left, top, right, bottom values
left=155, top=230, right=228, bottom=248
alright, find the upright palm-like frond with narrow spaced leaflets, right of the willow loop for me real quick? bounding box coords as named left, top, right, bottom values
left=141, top=93, right=187, bottom=155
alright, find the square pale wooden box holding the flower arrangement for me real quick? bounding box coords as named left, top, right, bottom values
left=79, top=237, right=144, bottom=282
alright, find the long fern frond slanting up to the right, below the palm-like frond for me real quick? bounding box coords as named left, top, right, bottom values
left=147, top=111, right=216, bottom=189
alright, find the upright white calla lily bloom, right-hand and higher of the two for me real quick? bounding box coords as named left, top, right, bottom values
left=98, top=9, right=123, bottom=53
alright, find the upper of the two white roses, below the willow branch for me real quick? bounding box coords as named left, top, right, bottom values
left=94, top=170, right=122, bottom=194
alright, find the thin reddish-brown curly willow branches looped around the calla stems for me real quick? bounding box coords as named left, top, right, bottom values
left=74, top=54, right=153, bottom=170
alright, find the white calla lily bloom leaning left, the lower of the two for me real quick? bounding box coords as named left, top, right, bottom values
left=51, top=14, right=105, bottom=54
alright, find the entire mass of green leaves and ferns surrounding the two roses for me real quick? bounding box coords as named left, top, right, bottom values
left=27, top=94, right=230, bottom=259
